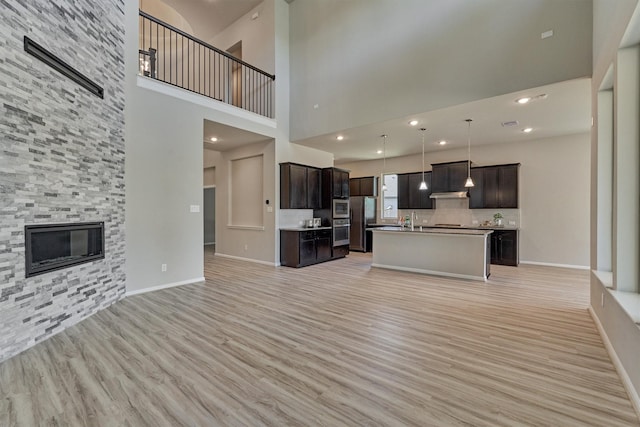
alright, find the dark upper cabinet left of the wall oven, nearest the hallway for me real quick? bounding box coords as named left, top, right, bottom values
left=280, top=163, right=322, bottom=209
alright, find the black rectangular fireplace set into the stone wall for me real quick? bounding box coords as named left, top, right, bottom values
left=24, top=222, right=104, bottom=277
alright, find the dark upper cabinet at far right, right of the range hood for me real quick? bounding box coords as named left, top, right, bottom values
left=469, top=163, right=520, bottom=209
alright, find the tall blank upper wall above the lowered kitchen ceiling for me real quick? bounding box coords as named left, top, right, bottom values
left=290, top=0, right=592, bottom=141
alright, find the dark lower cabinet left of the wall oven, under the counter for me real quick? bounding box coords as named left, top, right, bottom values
left=280, top=230, right=332, bottom=267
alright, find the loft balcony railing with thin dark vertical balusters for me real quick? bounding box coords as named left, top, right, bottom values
left=138, top=11, right=276, bottom=118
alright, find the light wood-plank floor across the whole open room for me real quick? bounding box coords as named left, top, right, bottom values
left=0, top=251, right=639, bottom=426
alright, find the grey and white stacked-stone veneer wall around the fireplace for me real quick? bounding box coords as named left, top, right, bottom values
left=0, top=0, right=125, bottom=361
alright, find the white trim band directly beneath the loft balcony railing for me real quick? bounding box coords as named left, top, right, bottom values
left=137, top=75, right=277, bottom=129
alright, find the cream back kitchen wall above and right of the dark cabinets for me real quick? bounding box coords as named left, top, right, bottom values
left=339, top=134, right=590, bottom=267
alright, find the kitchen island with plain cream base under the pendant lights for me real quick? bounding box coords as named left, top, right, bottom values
left=371, top=227, right=493, bottom=281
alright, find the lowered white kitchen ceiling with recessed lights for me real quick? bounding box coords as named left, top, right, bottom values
left=295, top=78, right=591, bottom=162
